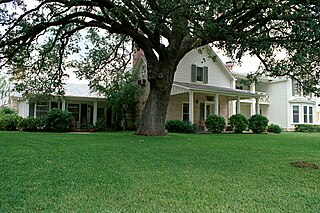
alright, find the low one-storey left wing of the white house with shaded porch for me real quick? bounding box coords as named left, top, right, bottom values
left=11, top=84, right=112, bottom=129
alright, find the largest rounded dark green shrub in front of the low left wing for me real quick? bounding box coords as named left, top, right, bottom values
left=43, top=108, right=72, bottom=132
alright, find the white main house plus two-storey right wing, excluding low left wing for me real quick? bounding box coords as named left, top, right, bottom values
left=135, top=46, right=319, bottom=131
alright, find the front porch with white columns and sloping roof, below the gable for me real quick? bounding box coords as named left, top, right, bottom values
left=167, top=82, right=260, bottom=128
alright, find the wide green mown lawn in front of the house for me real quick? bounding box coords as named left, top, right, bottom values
left=0, top=132, right=320, bottom=212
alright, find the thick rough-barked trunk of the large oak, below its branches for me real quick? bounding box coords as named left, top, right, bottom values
left=137, top=63, right=176, bottom=136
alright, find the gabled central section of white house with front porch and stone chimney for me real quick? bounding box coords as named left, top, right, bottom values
left=135, top=46, right=261, bottom=127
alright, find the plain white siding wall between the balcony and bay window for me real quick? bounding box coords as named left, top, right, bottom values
left=269, top=81, right=290, bottom=128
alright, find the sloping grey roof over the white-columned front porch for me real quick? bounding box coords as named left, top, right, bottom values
left=173, top=81, right=261, bottom=98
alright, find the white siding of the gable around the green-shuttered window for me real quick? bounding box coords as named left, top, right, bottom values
left=174, top=48, right=233, bottom=88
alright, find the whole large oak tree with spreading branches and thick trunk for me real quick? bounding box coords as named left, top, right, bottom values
left=0, top=0, right=320, bottom=135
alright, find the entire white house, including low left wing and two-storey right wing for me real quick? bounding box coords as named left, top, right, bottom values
left=10, top=46, right=320, bottom=130
